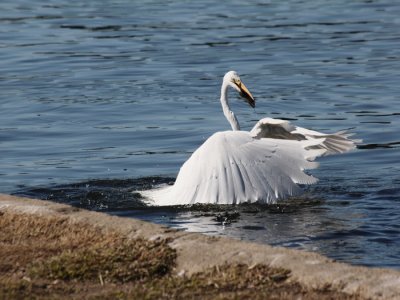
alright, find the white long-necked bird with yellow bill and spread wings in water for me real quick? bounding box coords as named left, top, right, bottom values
left=141, top=71, right=358, bottom=205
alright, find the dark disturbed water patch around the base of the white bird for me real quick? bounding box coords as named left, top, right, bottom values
left=14, top=177, right=323, bottom=226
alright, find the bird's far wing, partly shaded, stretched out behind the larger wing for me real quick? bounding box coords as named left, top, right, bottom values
left=250, top=118, right=361, bottom=155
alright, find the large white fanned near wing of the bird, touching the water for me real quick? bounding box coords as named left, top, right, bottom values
left=142, top=131, right=326, bottom=205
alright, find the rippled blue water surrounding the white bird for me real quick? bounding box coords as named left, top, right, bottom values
left=0, top=0, right=400, bottom=269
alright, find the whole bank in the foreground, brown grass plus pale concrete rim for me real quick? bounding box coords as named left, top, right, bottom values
left=0, top=195, right=400, bottom=299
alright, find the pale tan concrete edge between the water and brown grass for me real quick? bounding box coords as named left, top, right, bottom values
left=0, top=194, right=400, bottom=299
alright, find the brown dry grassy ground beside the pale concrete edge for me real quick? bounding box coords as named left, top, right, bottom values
left=0, top=211, right=361, bottom=299
